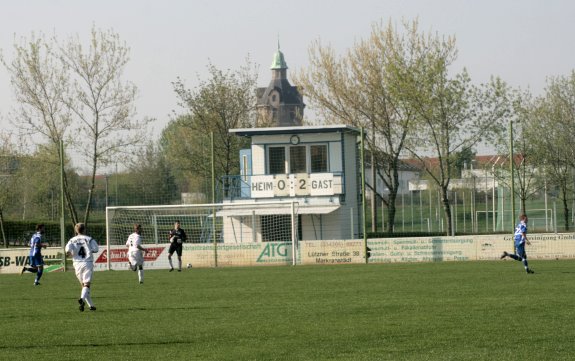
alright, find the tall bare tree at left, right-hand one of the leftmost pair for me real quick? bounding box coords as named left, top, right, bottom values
left=59, top=29, right=148, bottom=223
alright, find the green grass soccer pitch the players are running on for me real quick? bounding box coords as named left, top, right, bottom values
left=0, top=261, right=575, bottom=361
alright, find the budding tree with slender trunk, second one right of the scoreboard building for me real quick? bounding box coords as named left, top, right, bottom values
left=402, top=49, right=508, bottom=235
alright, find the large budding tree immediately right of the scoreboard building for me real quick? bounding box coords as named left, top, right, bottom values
left=295, top=21, right=425, bottom=233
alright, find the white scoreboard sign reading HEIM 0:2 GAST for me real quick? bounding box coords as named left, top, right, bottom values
left=250, top=173, right=342, bottom=198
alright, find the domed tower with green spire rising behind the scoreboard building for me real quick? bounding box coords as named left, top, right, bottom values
left=257, top=42, right=305, bottom=127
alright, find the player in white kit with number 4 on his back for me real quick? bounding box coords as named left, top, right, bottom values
left=66, top=223, right=98, bottom=312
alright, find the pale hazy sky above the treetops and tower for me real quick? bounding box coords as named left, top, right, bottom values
left=0, top=0, right=575, bottom=145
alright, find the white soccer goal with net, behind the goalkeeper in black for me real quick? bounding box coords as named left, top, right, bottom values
left=106, top=201, right=299, bottom=269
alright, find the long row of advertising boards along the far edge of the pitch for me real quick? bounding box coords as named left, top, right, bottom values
left=0, top=233, right=575, bottom=273
